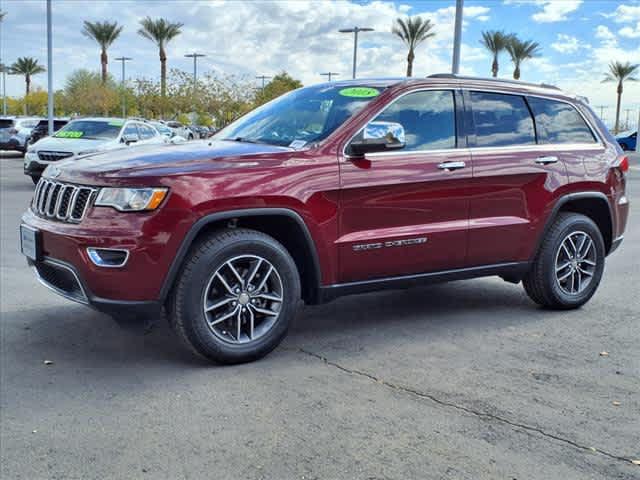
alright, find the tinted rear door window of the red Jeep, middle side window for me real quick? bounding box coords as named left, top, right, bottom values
left=471, top=92, right=536, bottom=147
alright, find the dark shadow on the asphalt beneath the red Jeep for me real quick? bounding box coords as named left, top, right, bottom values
left=3, top=280, right=556, bottom=369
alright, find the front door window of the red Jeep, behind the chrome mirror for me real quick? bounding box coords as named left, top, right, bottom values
left=375, top=90, right=456, bottom=150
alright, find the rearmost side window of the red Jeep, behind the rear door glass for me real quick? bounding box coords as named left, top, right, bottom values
left=527, top=97, right=596, bottom=143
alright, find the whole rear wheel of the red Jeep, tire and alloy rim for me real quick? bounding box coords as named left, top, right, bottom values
left=523, top=212, right=605, bottom=309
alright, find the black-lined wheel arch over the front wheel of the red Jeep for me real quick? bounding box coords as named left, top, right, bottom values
left=160, top=208, right=322, bottom=304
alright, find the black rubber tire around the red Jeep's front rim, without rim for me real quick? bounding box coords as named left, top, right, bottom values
left=169, top=229, right=300, bottom=364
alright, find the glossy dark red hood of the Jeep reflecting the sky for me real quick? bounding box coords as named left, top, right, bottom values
left=50, top=140, right=294, bottom=185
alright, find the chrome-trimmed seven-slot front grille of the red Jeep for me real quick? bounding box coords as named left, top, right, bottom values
left=31, top=178, right=95, bottom=223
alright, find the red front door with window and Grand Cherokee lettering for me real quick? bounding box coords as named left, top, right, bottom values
left=337, top=89, right=471, bottom=282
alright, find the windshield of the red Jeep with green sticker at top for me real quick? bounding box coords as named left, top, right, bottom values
left=217, top=85, right=382, bottom=148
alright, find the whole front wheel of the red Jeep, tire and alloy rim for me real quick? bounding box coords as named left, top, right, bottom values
left=170, top=229, right=300, bottom=363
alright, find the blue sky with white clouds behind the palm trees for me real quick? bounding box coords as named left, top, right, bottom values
left=0, top=0, right=640, bottom=124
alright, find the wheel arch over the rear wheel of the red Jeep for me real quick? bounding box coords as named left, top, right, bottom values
left=533, top=192, right=613, bottom=257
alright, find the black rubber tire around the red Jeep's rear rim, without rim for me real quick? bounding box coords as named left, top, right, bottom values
left=522, top=212, right=606, bottom=310
